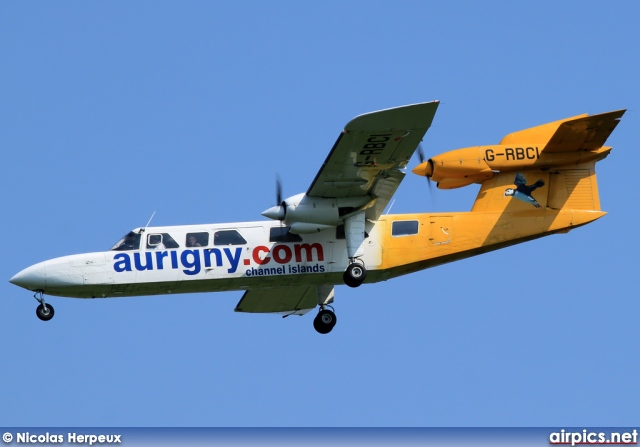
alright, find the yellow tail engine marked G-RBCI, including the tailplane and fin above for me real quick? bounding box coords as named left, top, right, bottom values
left=413, top=110, right=625, bottom=189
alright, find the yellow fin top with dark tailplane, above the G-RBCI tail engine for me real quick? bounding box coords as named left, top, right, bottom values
left=500, top=110, right=626, bottom=153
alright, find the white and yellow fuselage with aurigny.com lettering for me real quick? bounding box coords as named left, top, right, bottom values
left=11, top=209, right=604, bottom=298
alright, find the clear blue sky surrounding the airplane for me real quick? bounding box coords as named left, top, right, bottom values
left=0, top=1, right=640, bottom=426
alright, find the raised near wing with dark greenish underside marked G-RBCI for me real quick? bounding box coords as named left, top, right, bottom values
left=307, top=101, right=439, bottom=220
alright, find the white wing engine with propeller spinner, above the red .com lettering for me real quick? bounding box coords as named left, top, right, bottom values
left=262, top=193, right=373, bottom=234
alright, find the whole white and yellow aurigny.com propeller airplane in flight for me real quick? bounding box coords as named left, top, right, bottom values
left=10, top=101, right=625, bottom=334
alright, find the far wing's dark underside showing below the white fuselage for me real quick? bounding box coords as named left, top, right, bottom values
left=235, top=285, right=333, bottom=315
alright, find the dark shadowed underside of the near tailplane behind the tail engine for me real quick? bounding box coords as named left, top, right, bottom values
left=544, top=110, right=625, bottom=152
